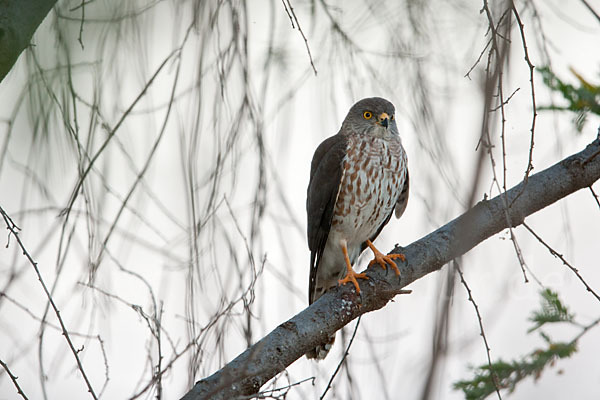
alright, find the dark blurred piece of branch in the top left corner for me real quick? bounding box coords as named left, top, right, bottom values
left=0, top=0, right=56, bottom=82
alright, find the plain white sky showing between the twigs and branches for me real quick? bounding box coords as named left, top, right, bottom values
left=0, top=1, right=600, bottom=399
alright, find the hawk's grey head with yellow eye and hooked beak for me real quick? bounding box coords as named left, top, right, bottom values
left=342, top=97, right=398, bottom=137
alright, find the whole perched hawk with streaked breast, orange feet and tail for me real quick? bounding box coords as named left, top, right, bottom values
left=306, top=97, right=408, bottom=359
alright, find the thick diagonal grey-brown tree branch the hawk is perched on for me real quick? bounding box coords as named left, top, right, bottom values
left=183, top=139, right=600, bottom=400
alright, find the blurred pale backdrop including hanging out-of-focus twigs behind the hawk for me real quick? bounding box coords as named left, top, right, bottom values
left=0, top=0, right=600, bottom=399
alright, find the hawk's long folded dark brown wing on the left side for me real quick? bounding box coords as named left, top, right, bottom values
left=306, top=134, right=347, bottom=303
